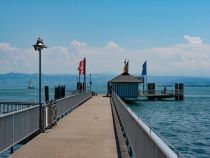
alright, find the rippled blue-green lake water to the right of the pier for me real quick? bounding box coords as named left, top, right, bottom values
left=130, top=87, right=210, bottom=158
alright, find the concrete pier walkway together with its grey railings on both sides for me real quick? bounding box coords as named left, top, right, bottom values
left=0, top=92, right=182, bottom=158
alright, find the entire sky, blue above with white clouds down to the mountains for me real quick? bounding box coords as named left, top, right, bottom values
left=0, top=0, right=210, bottom=76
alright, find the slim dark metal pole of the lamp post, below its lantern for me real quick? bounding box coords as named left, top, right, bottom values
left=39, top=49, right=42, bottom=129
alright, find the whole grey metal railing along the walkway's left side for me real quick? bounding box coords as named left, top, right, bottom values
left=0, top=92, right=92, bottom=152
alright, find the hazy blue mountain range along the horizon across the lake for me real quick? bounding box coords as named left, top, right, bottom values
left=0, top=73, right=210, bottom=89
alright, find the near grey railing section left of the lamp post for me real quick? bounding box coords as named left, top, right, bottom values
left=0, top=105, right=39, bottom=152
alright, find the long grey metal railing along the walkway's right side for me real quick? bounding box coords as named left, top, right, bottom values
left=112, top=92, right=179, bottom=158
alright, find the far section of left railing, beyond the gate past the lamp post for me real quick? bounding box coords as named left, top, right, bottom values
left=56, top=92, right=92, bottom=118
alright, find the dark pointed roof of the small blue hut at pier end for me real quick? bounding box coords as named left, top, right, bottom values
left=109, top=72, right=143, bottom=83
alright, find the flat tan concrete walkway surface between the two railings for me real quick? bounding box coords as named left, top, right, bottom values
left=10, top=96, right=117, bottom=158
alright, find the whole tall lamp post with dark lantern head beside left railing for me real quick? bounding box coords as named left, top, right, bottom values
left=33, top=38, right=47, bottom=130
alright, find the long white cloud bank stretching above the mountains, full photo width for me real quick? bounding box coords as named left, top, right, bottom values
left=0, top=36, right=210, bottom=76
